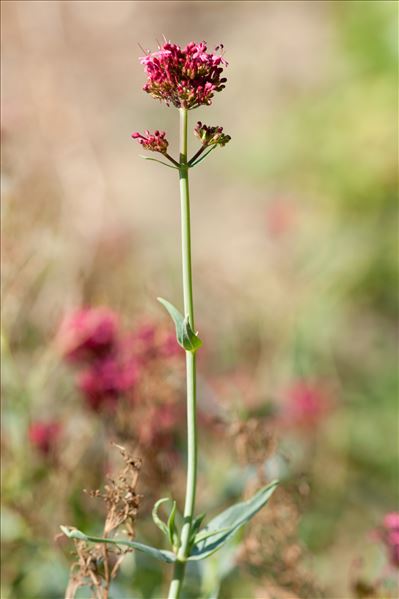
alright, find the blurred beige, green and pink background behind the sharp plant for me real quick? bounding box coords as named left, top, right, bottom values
left=1, top=1, right=399, bottom=599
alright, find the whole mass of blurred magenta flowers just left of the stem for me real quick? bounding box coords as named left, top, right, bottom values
left=58, top=308, right=178, bottom=411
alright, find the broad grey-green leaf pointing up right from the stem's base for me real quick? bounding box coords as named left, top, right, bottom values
left=188, top=481, right=278, bottom=561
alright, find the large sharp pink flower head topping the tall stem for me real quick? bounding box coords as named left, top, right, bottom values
left=140, top=42, right=227, bottom=110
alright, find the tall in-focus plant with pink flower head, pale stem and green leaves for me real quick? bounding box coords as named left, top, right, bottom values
left=63, top=42, right=277, bottom=599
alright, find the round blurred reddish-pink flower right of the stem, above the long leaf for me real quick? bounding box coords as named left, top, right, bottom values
left=282, top=380, right=331, bottom=429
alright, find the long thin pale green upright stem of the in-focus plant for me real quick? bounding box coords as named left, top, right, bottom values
left=168, top=108, right=197, bottom=599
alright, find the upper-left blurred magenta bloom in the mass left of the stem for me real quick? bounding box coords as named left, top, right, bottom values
left=58, top=308, right=119, bottom=363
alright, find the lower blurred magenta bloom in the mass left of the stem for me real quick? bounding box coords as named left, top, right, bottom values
left=77, top=357, right=138, bottom=411
